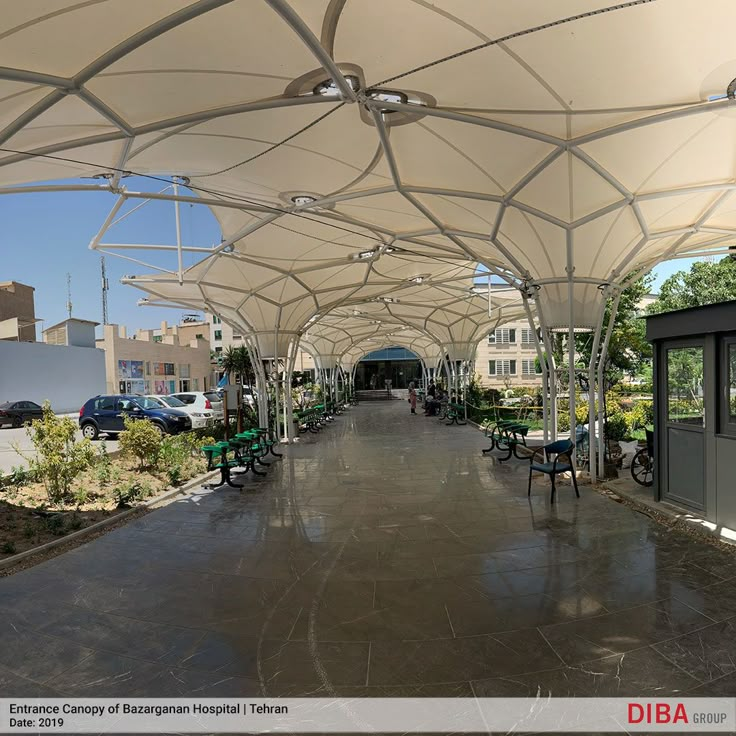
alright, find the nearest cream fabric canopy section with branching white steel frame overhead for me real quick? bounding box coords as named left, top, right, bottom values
left=0, top=0, right=736, bottom=362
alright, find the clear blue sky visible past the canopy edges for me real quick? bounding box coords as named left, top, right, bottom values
left=0, top=177, right=693, bottom=339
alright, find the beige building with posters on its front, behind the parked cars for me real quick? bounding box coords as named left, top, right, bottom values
left=96, top=322, right=212, bottom=394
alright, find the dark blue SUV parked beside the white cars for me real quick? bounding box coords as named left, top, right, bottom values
left=79, top=394, right=192, bottom=440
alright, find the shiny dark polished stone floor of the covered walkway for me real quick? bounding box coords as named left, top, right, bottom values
left=0, top=401, right=736, bottom=697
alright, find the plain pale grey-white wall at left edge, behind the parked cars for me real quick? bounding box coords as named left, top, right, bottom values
left=0, top=341, right=105, bottom=413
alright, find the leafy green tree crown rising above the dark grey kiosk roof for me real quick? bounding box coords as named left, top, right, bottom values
left=648, top=256, right=736, bottom=314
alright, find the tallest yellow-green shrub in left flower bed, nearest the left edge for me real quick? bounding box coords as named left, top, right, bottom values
left=22, top=401, right=94, bottom=504
